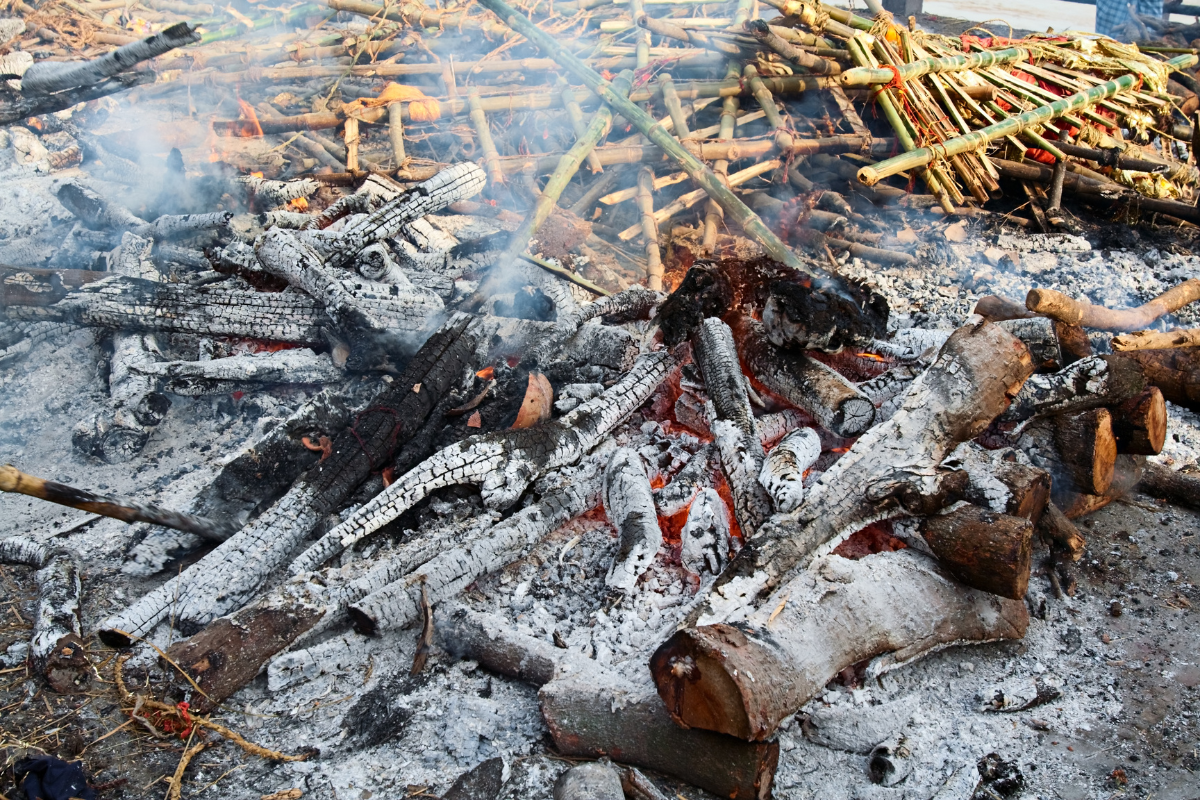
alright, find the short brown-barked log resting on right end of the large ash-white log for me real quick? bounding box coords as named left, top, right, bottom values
left=920, top=504, right=1033, bottom=600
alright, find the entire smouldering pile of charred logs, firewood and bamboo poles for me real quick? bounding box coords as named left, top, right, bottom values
left=0, top=0, right=1200, bottom=799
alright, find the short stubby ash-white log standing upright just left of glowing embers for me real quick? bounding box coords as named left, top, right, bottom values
left=604, top=447, right=662, bottom=594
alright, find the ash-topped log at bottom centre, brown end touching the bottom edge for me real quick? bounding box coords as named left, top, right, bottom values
left=437, top=608, right=779, bottom=800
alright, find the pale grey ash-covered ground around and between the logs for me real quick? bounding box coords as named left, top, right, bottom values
left=0, top=131, right=1200, bottom=800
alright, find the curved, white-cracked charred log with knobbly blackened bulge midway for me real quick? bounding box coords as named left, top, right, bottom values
left=292, top=351, right=674, bottom=572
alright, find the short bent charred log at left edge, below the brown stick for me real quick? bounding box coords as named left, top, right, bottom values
left=0, top=536, right=91, bottom=693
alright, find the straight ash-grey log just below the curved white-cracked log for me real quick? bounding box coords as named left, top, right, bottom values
left=349, top=462, right=602, bottom=636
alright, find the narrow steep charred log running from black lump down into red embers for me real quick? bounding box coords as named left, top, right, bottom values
left=692, top=317, right=770, bottom=536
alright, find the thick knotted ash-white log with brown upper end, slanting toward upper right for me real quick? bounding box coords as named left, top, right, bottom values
left=692, top=323, right=1033, bottom=621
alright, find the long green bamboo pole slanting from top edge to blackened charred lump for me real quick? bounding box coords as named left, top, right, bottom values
left=480, top=0, right=825, bottom=281
